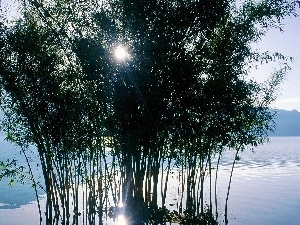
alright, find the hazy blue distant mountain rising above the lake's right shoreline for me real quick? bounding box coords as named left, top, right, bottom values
left=270, top=110, right=300, bottom=136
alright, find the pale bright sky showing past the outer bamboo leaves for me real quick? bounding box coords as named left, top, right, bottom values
left=0, top=0, right=300, bottom=112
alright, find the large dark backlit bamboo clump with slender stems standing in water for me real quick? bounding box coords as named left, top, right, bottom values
left=0, top=0, right=294, bottom=224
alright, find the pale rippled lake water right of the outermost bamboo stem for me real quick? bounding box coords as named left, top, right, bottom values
left=217, top=137, right=300, bottom=225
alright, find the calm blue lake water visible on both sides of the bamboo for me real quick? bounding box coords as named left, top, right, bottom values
left=0, top=137, right=300, bottom=225
